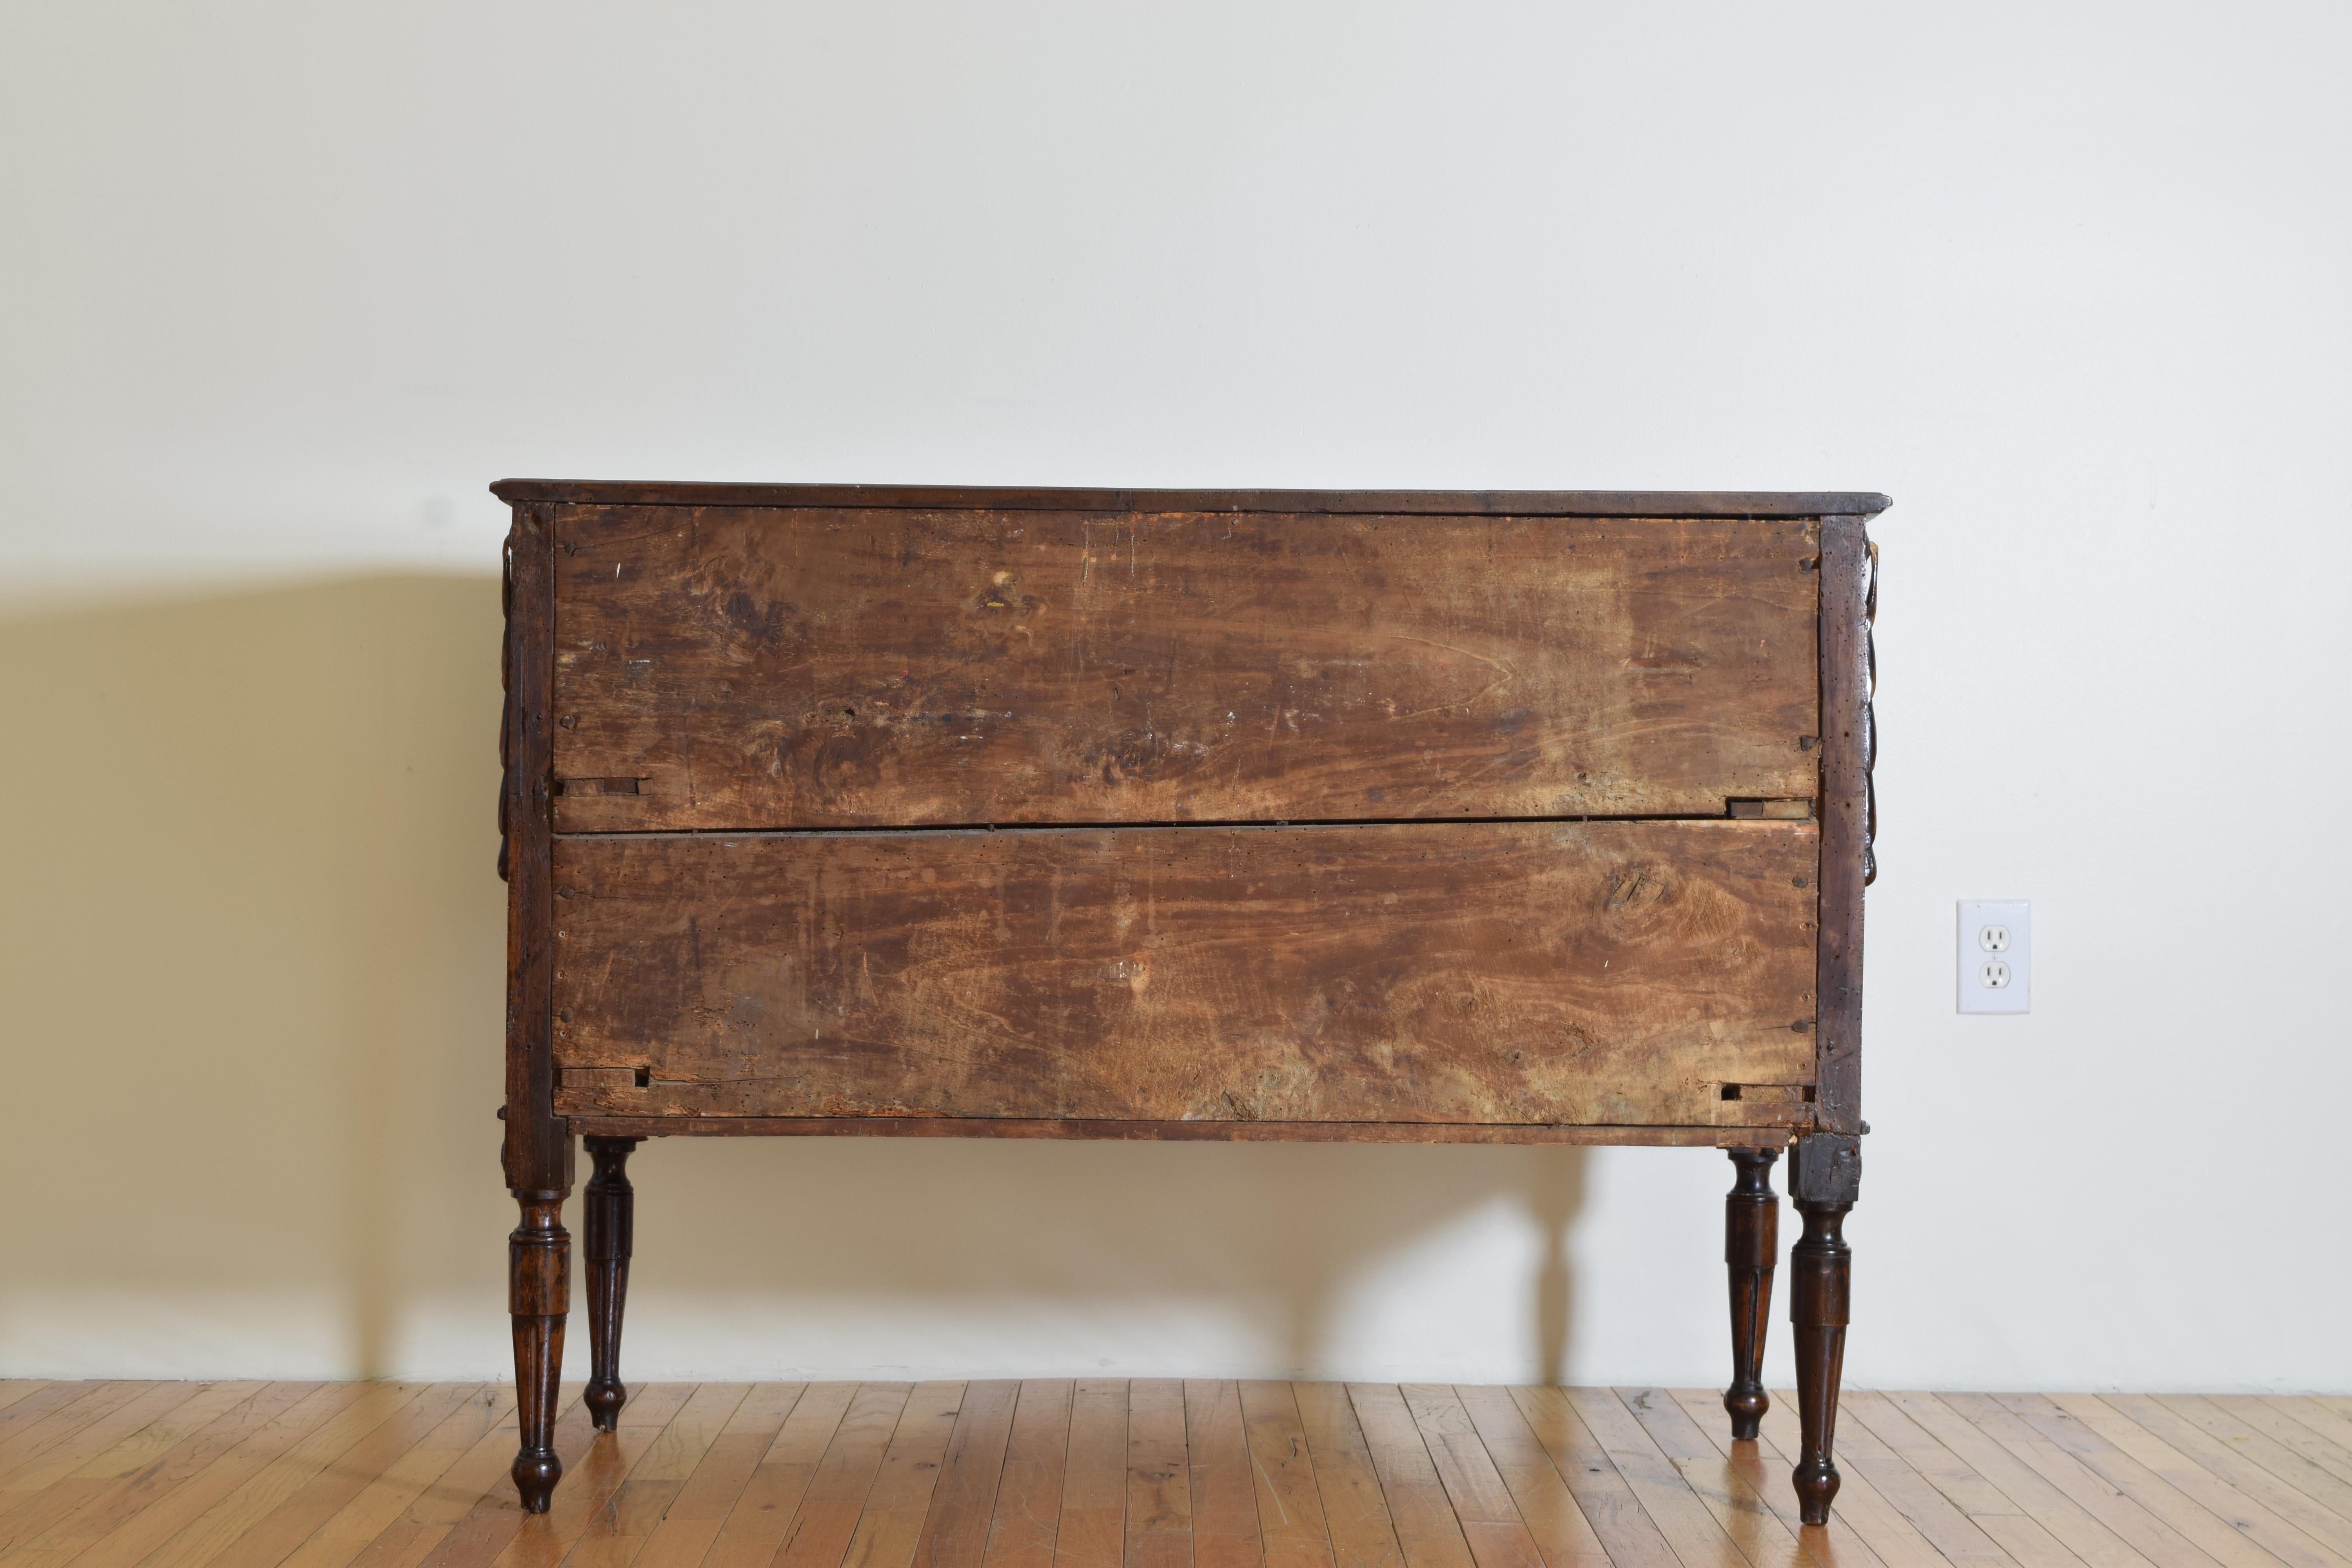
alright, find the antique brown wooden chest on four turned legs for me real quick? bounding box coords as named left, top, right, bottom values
left=494, top=479, right=1886, bottom=1521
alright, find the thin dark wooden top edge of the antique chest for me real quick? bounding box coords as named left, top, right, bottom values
left=489, top=479, right=1893, bottom=519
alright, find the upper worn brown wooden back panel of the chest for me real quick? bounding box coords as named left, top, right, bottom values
left=555, top=505, right=1820, bottom=832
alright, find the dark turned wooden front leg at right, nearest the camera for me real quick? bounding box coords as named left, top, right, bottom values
left=1788, top=1133, right=1863, bottom=1523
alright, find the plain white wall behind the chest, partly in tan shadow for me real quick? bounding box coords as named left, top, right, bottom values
left=0, top=0, right=2352, bottom=1389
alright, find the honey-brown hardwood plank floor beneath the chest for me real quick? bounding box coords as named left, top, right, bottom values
left=0, top=1377, right=2352, bottom=1568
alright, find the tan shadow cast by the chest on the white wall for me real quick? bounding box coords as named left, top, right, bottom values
left=0, top=576, right=1585, bottom=1380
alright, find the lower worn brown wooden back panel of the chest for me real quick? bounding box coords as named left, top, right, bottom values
left=555, top=820, right=1818, bottom=1126
